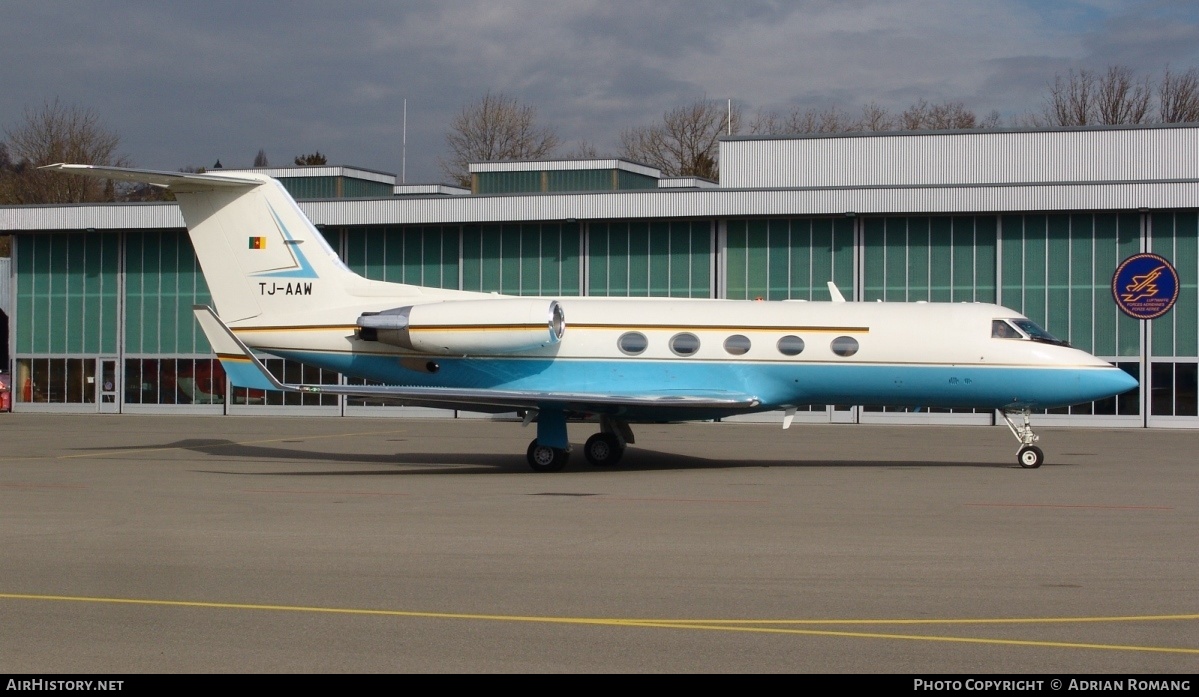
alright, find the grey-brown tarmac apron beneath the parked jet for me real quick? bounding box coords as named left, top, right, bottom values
left=0, top=414, right=1199, bottom=671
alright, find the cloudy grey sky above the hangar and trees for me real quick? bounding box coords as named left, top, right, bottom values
left=0, top=0, right=1199, bottom=184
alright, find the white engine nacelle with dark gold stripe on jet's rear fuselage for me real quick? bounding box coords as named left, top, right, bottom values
left=355, top=298, right=566, bottom=356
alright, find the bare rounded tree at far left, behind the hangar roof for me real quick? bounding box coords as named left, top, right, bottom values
left=0, top=98, right=129, bottom=204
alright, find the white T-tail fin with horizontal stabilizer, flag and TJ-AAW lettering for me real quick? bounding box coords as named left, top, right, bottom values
left=46, top=164, right=369, bottom=323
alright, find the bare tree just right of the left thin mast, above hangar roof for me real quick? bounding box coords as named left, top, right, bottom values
left=441, top=91, right=560, bottom=186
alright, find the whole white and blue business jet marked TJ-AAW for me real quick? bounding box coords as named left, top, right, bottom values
left=49, top=164, right=1137, bottom=471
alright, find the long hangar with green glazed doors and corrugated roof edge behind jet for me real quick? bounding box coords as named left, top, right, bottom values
left=0, top=125, right=1199, bottom=428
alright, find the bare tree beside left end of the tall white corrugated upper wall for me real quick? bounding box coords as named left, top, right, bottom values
left=620, top=98, right=741, bottom=180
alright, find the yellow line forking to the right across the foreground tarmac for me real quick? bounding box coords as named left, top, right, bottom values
left=0, top=593, right=1199, bottom=655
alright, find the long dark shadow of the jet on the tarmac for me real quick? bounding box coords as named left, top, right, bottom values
left=79, top=438, right=1031, bottom=476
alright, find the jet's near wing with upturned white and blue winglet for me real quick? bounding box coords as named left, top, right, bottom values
left=192, top=305, right=761, bottom=411
